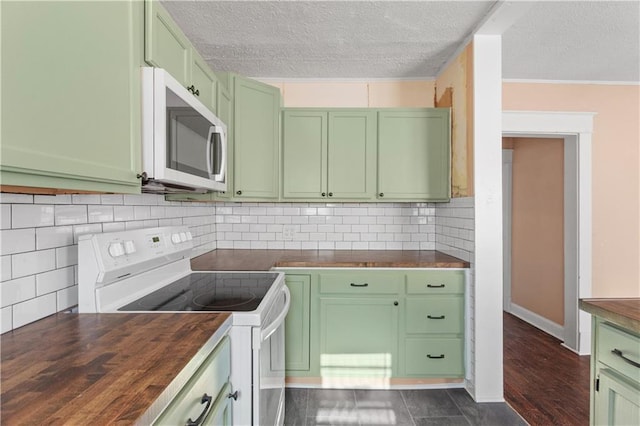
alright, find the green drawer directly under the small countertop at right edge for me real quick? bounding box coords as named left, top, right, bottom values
left=597, top=323, right=640, bottom=383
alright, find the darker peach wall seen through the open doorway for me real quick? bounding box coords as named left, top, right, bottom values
left=511, top=138, right=564, bottom=325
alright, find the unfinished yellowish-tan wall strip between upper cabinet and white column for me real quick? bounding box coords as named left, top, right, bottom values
left=436, top=44, right=473, bottom=197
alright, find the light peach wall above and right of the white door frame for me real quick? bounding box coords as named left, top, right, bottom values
left=502, top=83, right=640, bottom=297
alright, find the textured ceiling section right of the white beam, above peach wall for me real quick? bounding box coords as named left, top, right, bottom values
left=502, top=1, right=640, bottom=82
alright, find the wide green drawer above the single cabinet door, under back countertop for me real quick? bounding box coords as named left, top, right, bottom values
left=319, top=272, right=404, bottom=295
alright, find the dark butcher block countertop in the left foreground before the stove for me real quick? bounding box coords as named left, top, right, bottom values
left=1, top=313, right=231, bottom=425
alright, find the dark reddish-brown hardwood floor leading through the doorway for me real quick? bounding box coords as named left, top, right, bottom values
left=504, top=313, right=589, bottom=426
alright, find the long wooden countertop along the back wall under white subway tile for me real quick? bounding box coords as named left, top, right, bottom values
left=191, top=249, right=469, bottom=271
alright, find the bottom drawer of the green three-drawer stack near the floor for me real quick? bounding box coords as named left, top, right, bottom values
left=405, top=338, right=464, bottom=377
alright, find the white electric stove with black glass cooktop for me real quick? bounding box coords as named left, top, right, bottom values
left=78, top=226, right=290, bottom=426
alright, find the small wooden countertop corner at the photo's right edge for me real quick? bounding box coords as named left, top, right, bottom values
left=580, top=297, right=640, bottom=333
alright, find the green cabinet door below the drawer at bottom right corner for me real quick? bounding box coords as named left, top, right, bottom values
left=594, top=368, right=640, bottom=426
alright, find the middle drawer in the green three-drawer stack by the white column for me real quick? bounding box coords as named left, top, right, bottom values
left=405, top=296, right=464, bottom=334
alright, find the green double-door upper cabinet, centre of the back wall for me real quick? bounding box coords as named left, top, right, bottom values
left=282, top=108, right=376, bottom=200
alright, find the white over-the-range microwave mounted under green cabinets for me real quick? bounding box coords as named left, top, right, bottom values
left=142, top=67, right=227, bottom=193
